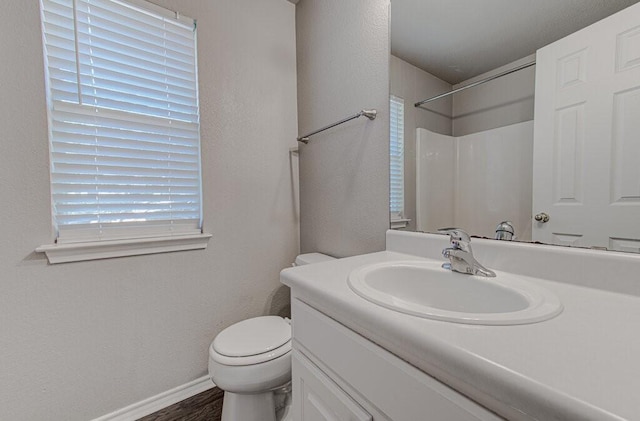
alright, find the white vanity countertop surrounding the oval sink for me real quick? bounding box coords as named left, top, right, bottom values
left=281, top=251, right=640, bottom=421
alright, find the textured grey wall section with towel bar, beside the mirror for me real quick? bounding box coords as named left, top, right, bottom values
left=296, top=0, right=389, bottom=257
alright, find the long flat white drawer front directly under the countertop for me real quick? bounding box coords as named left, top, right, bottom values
left=292, top=299, right=503, bottom=421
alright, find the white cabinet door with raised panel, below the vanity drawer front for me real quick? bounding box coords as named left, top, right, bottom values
left=291, top=351, right=373, bottom=421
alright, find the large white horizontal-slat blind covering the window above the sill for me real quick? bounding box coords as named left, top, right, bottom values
left=41, top=0, right=202, bottom=243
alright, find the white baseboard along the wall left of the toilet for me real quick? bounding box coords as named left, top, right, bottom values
left=93, top=376, right=215, bottom=421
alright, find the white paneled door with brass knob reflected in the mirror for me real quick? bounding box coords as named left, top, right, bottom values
left=533, top=3, right=640, bottom=252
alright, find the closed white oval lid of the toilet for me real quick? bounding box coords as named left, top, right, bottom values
left=213, top=316, right=291, bottom=357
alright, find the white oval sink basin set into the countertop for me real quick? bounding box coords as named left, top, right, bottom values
left=348, top=260, right=562, bottom=325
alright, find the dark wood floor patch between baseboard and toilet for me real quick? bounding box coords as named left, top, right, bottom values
left=138, top=387, right=224, bottom=421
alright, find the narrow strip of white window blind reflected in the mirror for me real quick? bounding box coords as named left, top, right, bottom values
left=389, top=95, right=404, bottom=220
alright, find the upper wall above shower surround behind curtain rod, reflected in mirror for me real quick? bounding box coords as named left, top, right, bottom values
left=453, top=54, right=536, bottom=136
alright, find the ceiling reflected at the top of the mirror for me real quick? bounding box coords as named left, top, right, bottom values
left=391, top=0, right=640, bottom=84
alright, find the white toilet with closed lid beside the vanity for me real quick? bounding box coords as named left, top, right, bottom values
left=209, top=253, right=334, bottom=421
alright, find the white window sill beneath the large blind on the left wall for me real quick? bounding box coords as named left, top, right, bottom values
left=36, top=234, right=211, bottom=264
